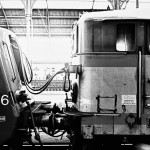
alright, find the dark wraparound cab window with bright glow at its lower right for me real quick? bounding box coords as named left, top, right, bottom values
left=83, top=20, right=135, bottom=52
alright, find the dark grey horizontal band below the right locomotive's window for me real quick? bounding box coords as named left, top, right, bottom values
left=78, top=54, right=138, bottom=67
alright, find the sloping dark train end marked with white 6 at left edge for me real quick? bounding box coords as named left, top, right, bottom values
left=0, top=28, right=22, bottom=143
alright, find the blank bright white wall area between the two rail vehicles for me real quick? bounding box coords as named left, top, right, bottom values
left=19, top=37, right=71, bottom=64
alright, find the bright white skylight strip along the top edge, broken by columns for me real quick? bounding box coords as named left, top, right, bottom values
left=0, top=0, right=150, bottom=10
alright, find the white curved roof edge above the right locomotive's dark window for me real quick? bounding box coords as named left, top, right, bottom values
left=80, top=9, right=150, bottom=21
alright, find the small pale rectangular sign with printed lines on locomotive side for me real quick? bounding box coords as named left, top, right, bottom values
left=122, top=95, right=136, bottom=105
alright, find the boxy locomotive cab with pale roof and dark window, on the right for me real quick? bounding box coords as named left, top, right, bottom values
left=69, top=10, right=150, bottom=146
